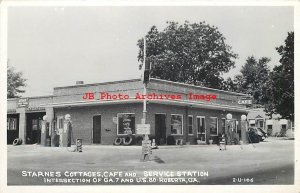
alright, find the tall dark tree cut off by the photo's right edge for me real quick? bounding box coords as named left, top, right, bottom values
left=265, top=32, right=295, bottom=120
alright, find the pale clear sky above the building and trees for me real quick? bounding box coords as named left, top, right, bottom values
left=7, top=6, right=294, bottom=97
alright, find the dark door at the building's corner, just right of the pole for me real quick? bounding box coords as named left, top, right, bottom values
left=155, top=114, right=166, bottom=145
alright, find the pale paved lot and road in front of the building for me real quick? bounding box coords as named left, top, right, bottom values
left=7, top=138, right=294, bottom=185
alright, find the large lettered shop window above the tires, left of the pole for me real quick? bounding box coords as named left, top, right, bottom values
left=118, top=113, right=135, bottom=135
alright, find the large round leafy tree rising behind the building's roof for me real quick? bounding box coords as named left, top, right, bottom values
left=137, top=21, right=237, bottom=88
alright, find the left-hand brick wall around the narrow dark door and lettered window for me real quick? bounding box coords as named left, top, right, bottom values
left=55, top=103, right=143, bottom=145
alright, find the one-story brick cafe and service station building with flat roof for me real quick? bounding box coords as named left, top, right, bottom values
left=7, top=78, right=249, bottom=146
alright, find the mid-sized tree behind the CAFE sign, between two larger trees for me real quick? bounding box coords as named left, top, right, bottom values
left=233, top=56, right=271, bottom=104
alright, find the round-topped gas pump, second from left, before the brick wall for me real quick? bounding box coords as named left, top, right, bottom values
left=59, top=114, right=72, bottom=147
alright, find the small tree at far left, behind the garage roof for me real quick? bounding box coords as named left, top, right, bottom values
left=7, top=66, right=26, bottom=98
